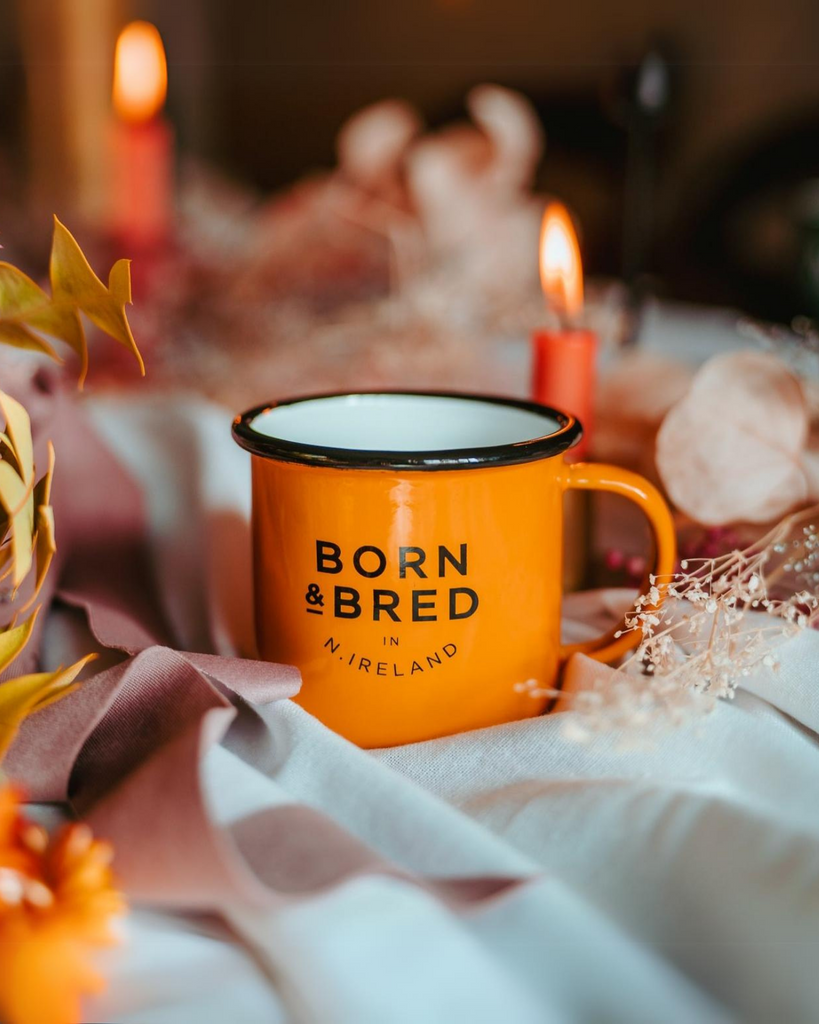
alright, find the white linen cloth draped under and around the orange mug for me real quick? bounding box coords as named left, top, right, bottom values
left=57, top=376, right=819, bottom=1024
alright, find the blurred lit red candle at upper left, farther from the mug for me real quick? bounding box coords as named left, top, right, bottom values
left=110, top=22, right=173, bottom=250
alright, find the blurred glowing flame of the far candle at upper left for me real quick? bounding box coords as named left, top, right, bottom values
left=114, top=22, right=168, bottom=122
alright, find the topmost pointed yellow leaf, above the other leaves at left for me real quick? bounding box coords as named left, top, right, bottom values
left=50, top=217, right=145, bottom=375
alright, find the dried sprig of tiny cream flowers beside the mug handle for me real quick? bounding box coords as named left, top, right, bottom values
left=548, top=506, right=819, bottom=746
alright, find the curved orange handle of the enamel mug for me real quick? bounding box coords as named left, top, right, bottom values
left=560, top=462, right=677, bottom=662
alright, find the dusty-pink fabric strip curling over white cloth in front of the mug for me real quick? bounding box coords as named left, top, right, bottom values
left=6, top=647, right=518, bottom=908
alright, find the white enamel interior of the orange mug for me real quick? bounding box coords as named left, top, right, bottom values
left=251, top=394, right=560, bottom=452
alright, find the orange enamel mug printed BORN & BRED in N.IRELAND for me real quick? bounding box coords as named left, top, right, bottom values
left=233, top=392, right=676, bottom=748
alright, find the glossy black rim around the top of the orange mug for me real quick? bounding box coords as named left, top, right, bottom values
left=232, top=388, right=583, bottom=472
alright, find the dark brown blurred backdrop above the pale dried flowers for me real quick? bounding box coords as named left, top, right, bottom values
left=0, top=0, right=819, bottom=322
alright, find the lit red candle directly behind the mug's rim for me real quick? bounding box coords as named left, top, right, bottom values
left=532, top=203, right=597, bottom=459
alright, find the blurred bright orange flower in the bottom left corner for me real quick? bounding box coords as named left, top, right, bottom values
left=0, top=786, right=125, bottom=1024
